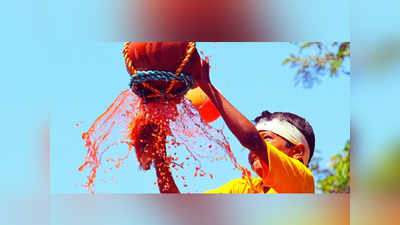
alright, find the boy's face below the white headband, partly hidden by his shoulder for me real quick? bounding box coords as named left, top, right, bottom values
left=248, top=130, right=295, bottom=177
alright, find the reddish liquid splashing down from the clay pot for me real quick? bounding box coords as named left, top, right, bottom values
left=79, top=89, right=250, bottom=193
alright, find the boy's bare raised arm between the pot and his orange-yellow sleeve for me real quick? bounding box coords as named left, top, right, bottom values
left=200, top=83, right=268, bottom=163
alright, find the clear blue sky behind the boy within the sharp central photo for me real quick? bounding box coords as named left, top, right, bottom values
left=47, top=42, right=350, bottom=193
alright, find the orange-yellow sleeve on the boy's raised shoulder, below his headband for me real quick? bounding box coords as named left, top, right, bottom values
left=263, top=142, right=315, bottom=193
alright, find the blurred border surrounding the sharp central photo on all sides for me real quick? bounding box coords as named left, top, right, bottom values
left=4, top=0, right=400, bottom=224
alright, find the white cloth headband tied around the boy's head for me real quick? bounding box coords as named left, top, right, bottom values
left=256, top=118, right=310, bottom=165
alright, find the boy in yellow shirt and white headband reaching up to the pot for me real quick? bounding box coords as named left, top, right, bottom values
left=155, top=58, right=315, bottom=193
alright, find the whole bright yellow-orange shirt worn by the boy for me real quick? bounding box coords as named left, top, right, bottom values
left=204, top=142, right=315, bottom=194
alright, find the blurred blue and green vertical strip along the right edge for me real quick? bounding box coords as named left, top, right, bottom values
left=350, top=1, right=400, bottom=224
